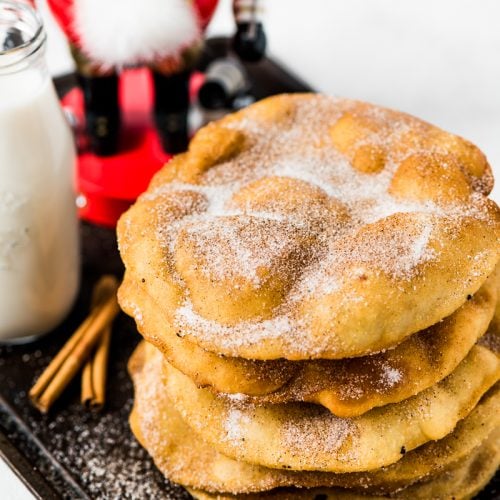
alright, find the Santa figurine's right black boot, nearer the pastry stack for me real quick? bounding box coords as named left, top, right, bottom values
left=153, top=71, right=191, bottom=154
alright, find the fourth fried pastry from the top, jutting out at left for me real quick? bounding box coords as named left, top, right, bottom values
left=129, top=342, right=500, bottom=494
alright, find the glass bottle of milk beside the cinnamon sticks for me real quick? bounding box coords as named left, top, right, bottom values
left=0, top=0, right=79, bottom=342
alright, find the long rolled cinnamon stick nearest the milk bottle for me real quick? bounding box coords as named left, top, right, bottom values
left=29, top=276, right=119, bottom=413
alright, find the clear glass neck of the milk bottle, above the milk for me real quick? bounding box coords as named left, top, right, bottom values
left=0, top=0, right=48, bottom=77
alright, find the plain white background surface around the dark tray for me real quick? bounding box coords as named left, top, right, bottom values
left=0, top=0, right=500, bottom=494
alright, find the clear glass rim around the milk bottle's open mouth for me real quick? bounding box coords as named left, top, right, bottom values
left=0, top=0, right=47, bottom=71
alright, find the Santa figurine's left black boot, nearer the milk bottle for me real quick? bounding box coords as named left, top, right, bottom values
left=78, top=74, right=121, bottom=156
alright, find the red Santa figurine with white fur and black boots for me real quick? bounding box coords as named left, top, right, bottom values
left=43, top=0, right=265, bottom=156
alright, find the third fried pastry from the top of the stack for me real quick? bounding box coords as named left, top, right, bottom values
left=161, top=340, right=500, bottom=472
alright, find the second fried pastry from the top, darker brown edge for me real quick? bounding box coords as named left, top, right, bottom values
left=120, top=272, right=498, bottom=417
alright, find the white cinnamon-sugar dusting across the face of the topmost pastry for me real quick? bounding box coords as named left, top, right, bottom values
left=136, top=96, right=496, bottom=355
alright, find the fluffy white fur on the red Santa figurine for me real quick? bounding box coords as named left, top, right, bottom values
left=75, top=0, right=200, bottom=67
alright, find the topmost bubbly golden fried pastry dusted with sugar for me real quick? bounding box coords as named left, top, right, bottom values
left=118, top=94, right=500, bottom=360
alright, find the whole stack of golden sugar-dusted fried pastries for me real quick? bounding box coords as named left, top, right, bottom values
left=118, top=94, right=500, bottom=499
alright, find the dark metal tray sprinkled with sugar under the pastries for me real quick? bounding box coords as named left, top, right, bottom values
left=0, top=39, right=500, bottom=500
